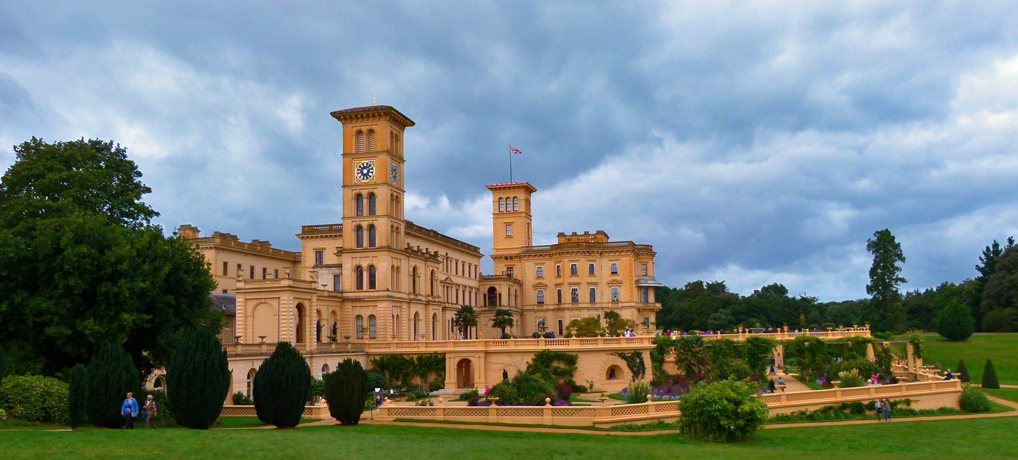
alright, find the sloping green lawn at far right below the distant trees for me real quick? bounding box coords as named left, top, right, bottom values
left=922, top=334, right=1018, bottom=385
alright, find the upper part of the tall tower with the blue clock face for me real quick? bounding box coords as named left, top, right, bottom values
left=331, top=106, right=414, bottom=253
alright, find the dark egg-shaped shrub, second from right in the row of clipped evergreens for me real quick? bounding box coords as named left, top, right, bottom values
left=252, top=342, right=312, bottom=428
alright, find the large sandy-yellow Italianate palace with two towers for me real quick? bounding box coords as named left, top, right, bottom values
left=172, top=106, right=661, bottom=394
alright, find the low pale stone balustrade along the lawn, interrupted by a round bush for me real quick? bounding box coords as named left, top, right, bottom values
left=379, top=380, right=962, bottom=426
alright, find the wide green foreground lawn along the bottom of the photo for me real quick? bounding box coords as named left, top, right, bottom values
left=0, top=417, right=1018, bottom=460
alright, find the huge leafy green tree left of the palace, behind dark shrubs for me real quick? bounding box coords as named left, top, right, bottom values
left=0, top=138, right=222, bottom=375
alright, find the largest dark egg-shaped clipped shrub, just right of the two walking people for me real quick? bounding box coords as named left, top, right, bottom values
left=166, top=329, right=230, bottom=429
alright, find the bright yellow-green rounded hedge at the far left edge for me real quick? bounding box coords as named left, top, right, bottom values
left=0, top=376, right=67, bottom=423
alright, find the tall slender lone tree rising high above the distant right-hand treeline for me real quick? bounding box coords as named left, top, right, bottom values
left=866, top=229, right=907, bottom=332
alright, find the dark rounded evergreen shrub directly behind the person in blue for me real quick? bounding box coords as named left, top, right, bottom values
left=86, top=345, right=142, bottom=428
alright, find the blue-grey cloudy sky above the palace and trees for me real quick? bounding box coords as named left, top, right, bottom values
left=0, top=1, right=1018, bottom=300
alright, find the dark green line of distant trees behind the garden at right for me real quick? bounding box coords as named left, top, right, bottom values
left=657, top=237, right=1018, bottom=333
